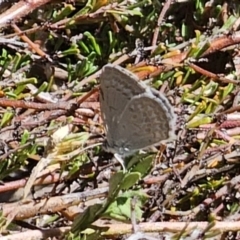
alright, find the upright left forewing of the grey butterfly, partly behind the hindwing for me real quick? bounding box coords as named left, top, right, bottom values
left=100, top=64, right=145, bottom=145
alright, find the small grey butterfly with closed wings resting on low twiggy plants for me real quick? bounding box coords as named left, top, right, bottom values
left=100, top=64, right=176, bottom=156
